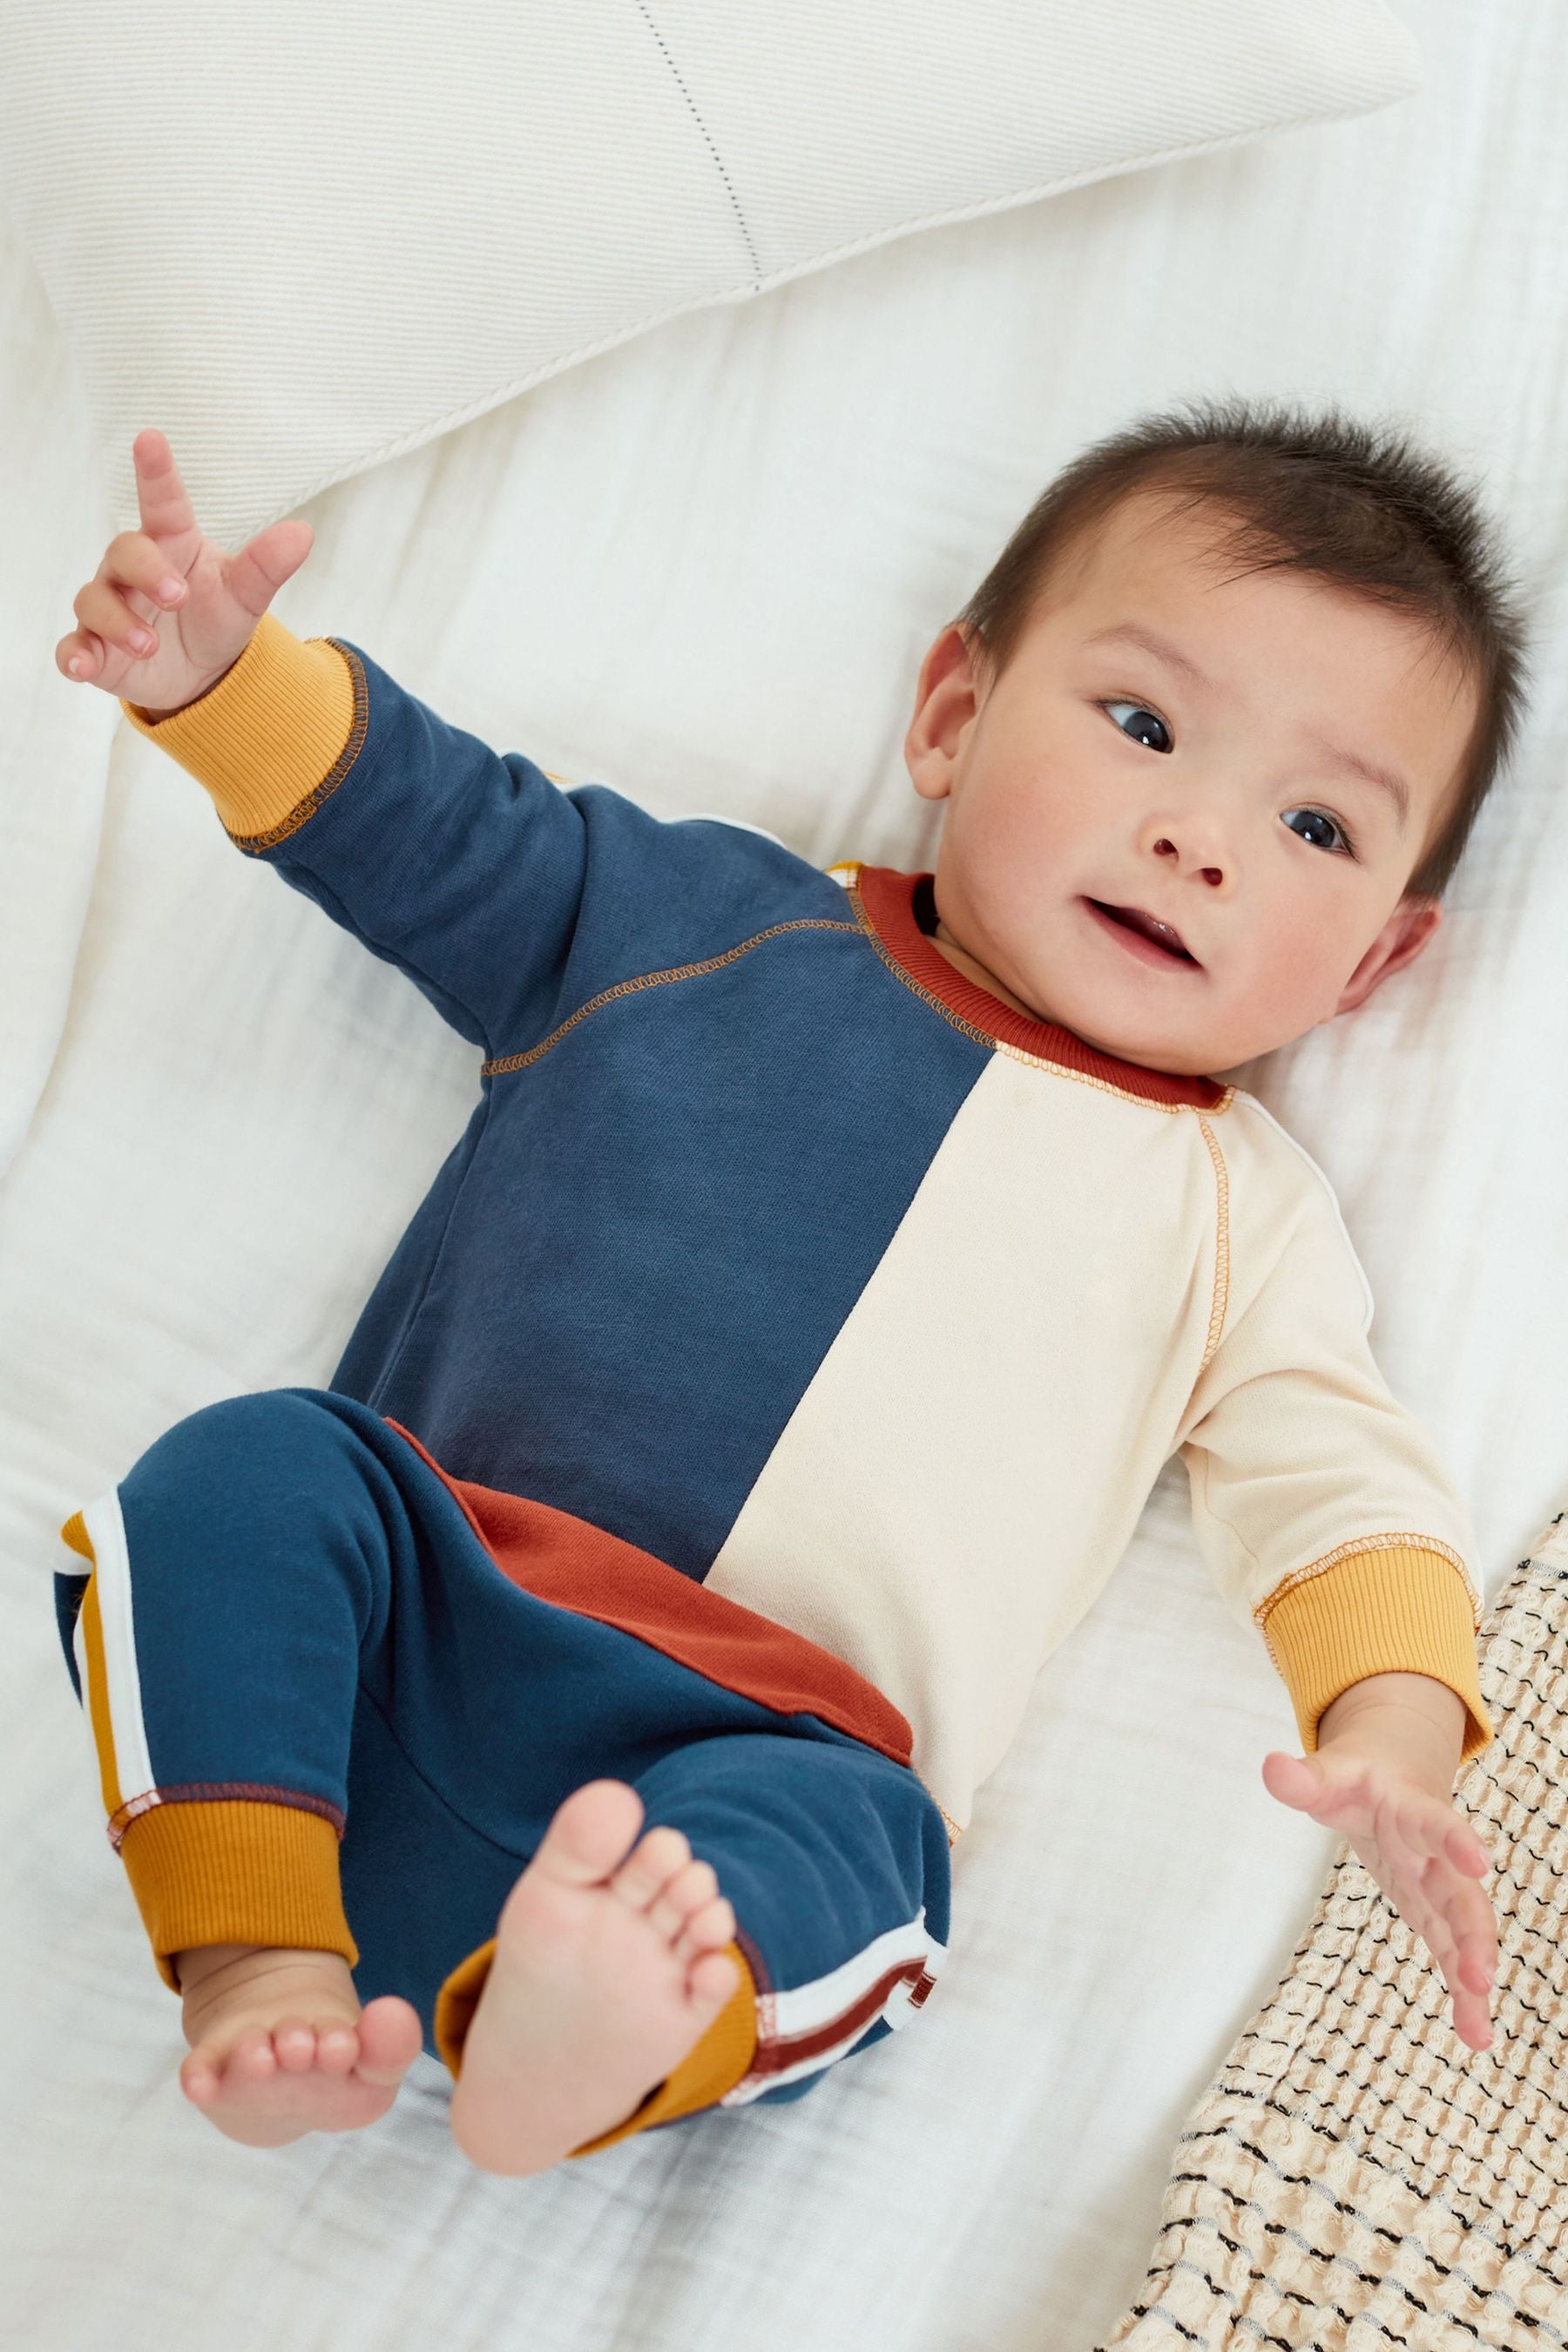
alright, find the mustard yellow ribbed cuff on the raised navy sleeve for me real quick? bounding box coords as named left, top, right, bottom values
left=120, top=612, right=367, bottom=849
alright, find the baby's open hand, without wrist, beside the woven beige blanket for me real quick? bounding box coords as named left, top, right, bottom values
left=1262, top=1734, right=1497, bottom=2051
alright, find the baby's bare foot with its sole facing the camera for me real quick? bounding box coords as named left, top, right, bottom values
left=451, top=1781, right=738, bottom=2173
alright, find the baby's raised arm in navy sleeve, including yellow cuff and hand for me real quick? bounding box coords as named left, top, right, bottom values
left=57, top=428, right=601, bottom=1054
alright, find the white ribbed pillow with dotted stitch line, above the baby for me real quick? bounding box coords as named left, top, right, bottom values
left=0, top=0, right=1417, bottom=545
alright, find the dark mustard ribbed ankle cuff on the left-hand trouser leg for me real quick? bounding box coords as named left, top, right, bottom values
left=120, top=1797, right=360, bottom=1992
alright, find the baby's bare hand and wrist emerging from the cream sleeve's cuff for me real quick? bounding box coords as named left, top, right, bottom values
left=1262, top=1674, right=1497, bottom=2051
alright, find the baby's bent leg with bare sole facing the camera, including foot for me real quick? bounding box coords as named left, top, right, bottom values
left=437, top=1710, right=950, bottom=2173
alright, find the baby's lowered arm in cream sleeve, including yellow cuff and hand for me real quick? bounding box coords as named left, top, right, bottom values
left=1182, top=1138, right=1497, bottom=2049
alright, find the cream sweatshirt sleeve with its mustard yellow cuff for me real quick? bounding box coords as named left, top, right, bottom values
left=1178, top=1132, right=1495, bottom=1761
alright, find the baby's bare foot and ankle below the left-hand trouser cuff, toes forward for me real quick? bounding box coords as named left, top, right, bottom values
left=174, top=1943, right=421, bottom=2147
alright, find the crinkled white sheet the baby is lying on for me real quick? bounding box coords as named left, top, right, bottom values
left=0, top=0, right=1568, bottom=2352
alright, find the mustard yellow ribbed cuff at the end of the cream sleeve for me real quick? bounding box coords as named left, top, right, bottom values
left=1262, top=1541, right=1495, bottom=1764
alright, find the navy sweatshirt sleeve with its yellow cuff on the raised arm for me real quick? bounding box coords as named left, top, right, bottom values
left=120, top=614, right=594, bottom=1051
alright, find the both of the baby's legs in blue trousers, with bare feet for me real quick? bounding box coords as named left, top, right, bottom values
left=57, top=1390, right=948, bottom=2171
